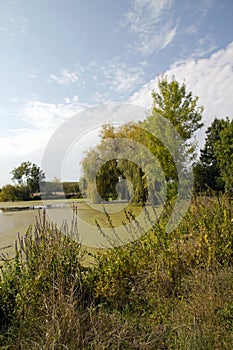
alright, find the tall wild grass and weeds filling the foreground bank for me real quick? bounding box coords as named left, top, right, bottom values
left=0, top=197, right=233, bottom=350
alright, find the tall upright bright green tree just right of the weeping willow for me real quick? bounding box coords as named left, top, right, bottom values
left=145, top=75, right=204, bottom=197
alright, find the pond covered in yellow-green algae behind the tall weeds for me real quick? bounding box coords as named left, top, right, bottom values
left=0, top=200, right=161, bottom=257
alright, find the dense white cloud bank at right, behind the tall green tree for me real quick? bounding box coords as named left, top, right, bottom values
left=129, top=42, right=233, bottom=142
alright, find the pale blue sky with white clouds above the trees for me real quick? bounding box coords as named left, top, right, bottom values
left=0, top=0, right=233, bottom=187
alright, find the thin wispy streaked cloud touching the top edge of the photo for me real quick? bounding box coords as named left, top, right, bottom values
left=120, top=0, right=177, bottom=55
